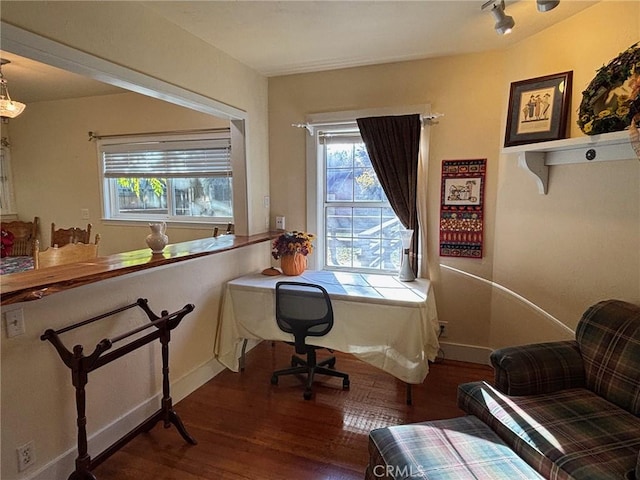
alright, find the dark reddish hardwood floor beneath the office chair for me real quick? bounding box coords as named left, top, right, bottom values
left=90, top=342, right=493, bottom=480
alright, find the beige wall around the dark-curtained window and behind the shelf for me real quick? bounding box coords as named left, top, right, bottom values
left=269, top=2, right=640, bottom=358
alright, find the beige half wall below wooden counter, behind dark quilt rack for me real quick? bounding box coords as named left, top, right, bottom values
left=0, top=242, right=270, bottom=480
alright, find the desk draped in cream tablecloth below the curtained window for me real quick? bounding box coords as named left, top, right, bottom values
left=214, top=271, right=439, bottom=384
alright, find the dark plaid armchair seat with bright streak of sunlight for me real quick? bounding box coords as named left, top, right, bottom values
left=458, top=382, right=640, bottom=480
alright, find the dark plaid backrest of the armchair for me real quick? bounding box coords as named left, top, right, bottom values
left=576, top=300, right=640, bottom=416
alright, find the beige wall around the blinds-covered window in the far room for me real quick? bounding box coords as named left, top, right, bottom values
left=3, top=93, right=229, bottom=255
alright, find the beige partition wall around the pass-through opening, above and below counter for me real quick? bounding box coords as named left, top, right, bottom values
left=0, top=1, right=269, bottom=480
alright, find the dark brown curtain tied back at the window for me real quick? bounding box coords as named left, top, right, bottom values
left=356, top=114, right=422, bottom=275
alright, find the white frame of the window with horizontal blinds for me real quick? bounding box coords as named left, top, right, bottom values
left=96, top=128, right=236, bottom=225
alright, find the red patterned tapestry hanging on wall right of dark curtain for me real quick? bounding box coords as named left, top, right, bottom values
left=440, top=159, right=487, bottom=258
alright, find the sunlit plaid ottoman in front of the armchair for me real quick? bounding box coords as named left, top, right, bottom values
left=365, top=415, right=542, bottom=480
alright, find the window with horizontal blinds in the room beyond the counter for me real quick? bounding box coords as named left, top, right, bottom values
left=98, top=130, right=233, bottom=223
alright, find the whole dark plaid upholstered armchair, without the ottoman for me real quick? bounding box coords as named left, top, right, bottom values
left=458, top=300, right=640, bottom=480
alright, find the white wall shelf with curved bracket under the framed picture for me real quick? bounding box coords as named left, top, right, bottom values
left=502, top=130, right=636, bottom=195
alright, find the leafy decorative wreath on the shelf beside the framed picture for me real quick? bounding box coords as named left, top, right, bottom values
left=578, top=42, right=640, bottom=135
